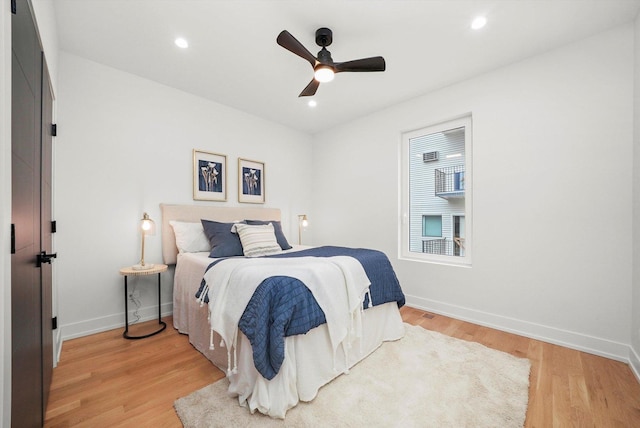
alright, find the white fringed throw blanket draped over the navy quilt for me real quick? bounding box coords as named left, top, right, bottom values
left=201, top=256, right=370, bottom=375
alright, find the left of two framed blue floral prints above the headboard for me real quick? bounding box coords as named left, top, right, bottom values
left=193, top=149, right=227, bottom=201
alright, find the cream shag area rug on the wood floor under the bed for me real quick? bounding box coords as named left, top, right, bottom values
left=174, top=324, right=531, bottom=428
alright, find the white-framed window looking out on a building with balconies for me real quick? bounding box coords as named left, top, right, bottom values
left=400, top=116, right=472, bottom=265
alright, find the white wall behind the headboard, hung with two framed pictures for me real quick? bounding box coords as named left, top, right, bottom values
left=55, top=52, right=312, bottom=338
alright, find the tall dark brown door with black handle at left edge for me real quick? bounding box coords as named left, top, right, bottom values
left=11, top=0, right=53, bottom=427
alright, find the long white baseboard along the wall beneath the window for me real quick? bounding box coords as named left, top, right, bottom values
left=405, top=295, right=628, bottom=367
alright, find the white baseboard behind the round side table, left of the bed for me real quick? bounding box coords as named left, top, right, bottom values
left=58, top=303, right=173, bottom=342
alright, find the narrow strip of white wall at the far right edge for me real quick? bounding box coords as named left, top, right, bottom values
left=629, top=14, right=640, bottom=381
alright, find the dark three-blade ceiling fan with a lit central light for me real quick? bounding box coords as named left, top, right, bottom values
left=276, top=28, right=385, bottom=97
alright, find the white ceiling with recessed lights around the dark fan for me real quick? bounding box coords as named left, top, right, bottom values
left=54, top=0, right=640, bottom=133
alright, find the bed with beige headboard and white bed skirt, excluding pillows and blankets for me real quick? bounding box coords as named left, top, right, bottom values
left=161, top=204, right=404, bottom=418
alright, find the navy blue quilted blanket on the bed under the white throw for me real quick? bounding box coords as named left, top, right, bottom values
left=196, top=246, right=405, bottom=380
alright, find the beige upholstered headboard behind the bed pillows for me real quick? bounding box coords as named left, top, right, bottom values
left=160, top=204, right=280, bottom=265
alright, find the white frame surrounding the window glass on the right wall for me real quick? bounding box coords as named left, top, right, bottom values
left=398, top=113, right=473, bottom=267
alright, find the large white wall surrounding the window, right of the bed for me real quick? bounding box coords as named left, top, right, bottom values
left=313, top=25, right=634, bottom=359
